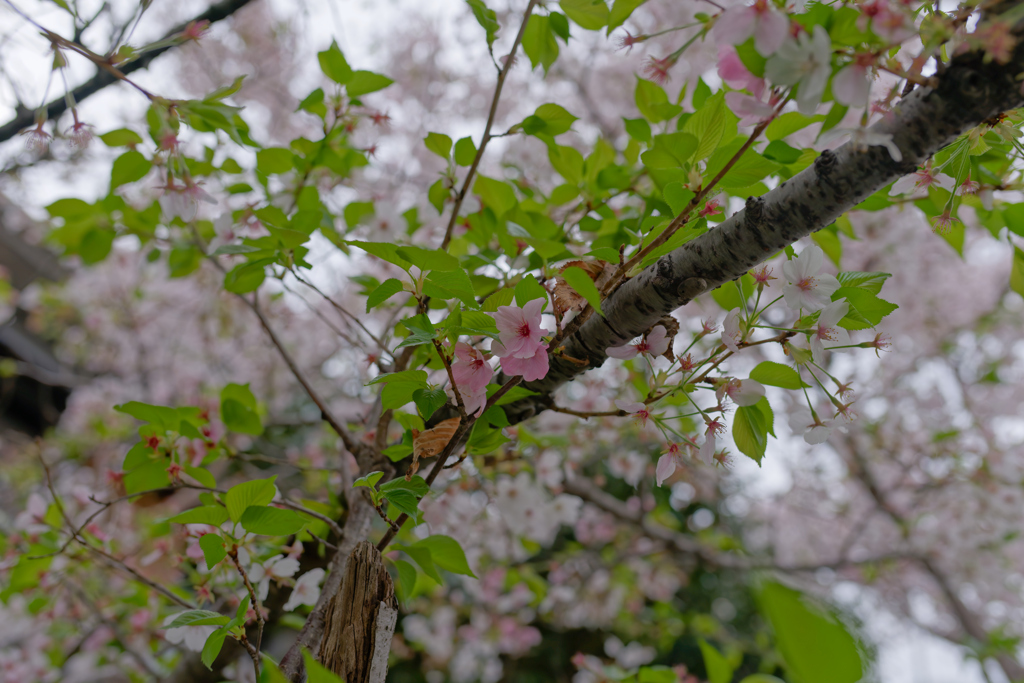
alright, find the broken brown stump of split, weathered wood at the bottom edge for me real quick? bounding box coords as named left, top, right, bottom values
left=318, top=541, right=398, bottom=683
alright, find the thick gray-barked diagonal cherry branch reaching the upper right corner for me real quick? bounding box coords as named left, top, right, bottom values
left=505, top=45, right=1024, bottom=423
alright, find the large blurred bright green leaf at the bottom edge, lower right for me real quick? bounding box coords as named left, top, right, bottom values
left=758, top=582, right=864, bottom=683
